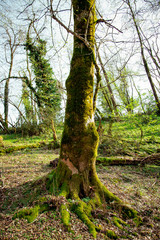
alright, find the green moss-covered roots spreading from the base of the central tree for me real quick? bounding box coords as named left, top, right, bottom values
left=13, top=170, right=141, bottom=239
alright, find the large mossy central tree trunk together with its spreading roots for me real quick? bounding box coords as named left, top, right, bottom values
left=15, top=0, right=141, bottom=238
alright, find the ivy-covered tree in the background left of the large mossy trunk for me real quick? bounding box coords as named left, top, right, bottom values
left=25, top=25, right=61, bottom=136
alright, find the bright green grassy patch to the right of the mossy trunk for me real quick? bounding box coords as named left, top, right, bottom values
left=99, top=116, right=160, bottom=156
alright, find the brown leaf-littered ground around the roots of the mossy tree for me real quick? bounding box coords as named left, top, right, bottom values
left=0, top=149, right=160, bottom=240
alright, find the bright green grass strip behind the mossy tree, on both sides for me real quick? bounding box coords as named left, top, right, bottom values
left=0, top=115, right=160, bottom=156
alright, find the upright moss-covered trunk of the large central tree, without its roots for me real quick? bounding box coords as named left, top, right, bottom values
left=57, top=0, right=98, bottom=197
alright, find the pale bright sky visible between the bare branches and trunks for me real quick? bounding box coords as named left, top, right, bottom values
left=0, top=0, right=160, bottom=122
